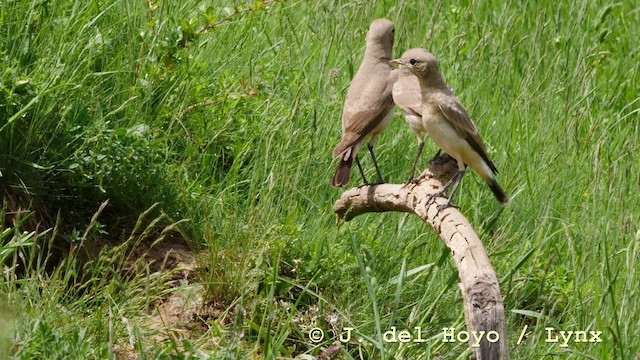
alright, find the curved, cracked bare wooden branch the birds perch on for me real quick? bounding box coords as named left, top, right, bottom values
left=333, top=156, right=509, bottom=360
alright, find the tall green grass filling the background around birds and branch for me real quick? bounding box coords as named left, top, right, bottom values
left=0, top=0, right=640, bottom=359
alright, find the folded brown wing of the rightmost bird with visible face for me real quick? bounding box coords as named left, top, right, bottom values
left=433, top=93, right=498, bottom=174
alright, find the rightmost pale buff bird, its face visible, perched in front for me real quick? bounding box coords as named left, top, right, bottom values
left=390, top=48, right=509, bottom=208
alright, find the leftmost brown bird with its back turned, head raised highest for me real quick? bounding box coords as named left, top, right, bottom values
left=331, top=19, right=397, bottom=187
